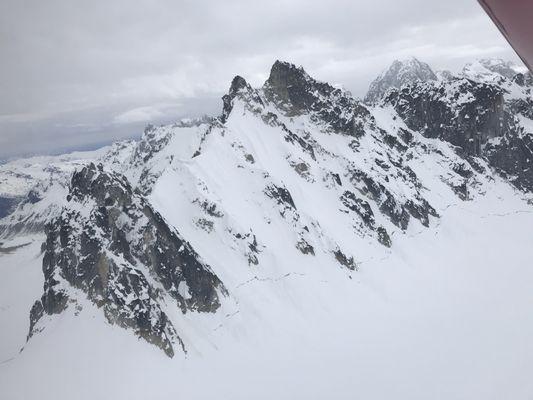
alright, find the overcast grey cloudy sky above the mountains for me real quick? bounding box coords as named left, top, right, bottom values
left=0, top=0, right=518, bottom=159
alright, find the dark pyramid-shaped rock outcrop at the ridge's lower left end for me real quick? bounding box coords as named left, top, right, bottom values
left=30, top=164, right=225, bottom=356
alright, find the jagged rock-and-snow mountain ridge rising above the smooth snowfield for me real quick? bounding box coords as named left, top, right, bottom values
left=2, top=60, right=533, bottom=357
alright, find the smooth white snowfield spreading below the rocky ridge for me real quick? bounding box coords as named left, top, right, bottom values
left=0, top=185, right=533, bottom=400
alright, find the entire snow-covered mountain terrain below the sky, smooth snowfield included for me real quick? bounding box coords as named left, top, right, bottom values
left=0, top=59, right=533, bottom=398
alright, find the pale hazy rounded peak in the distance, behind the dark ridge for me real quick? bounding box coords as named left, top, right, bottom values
left=365, top=57, right=439, bottom=104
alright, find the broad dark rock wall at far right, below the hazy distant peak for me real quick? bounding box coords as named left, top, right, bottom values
left=384, top=74, right=533, bottom=194
